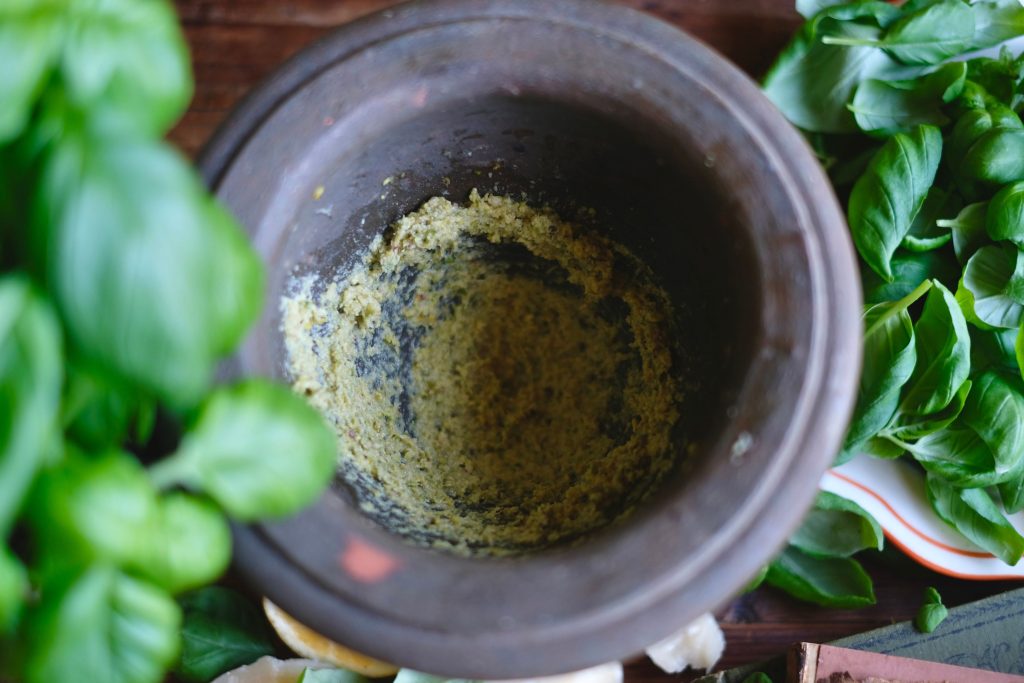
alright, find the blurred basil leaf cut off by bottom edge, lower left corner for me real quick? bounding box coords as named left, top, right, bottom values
left=26, top=565, right=181, bottom=683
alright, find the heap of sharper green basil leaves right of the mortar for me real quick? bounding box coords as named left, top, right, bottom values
left=764, top=0, right=1024, bottom=598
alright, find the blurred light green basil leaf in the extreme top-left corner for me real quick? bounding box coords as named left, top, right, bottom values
left=0, top=0, right=63, bottom=143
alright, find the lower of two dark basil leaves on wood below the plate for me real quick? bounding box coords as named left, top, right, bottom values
left=765, top=547, right=874, bottom=608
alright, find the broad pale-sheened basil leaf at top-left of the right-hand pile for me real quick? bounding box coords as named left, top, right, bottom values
left=764, top=14, right=898, bottom=133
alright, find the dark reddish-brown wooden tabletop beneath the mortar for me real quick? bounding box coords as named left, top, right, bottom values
left=170, top=0, right=1017, bottom=683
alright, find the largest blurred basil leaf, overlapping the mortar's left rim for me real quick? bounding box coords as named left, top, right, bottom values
left=32, top=129, right=262, bottom=405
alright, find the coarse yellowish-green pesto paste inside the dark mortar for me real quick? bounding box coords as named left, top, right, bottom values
left=283, top=190, right=684, bottom=554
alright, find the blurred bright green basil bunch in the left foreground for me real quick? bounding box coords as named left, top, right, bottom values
left=0, top=0, right=335, bottom=683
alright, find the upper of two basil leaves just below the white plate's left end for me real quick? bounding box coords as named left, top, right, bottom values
left=790, top=492, right=885, bottom=557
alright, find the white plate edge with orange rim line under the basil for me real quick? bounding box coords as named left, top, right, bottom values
left=820, top=456, right=1024, bottom=581
